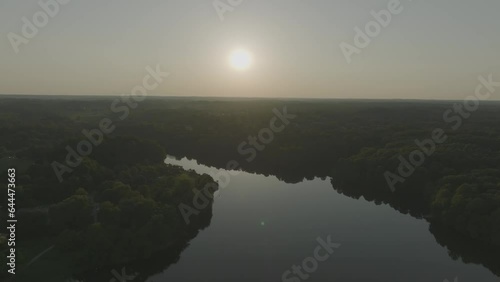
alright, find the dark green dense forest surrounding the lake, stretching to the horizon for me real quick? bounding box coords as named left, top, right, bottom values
left=0, top=97, right=500, bottom=280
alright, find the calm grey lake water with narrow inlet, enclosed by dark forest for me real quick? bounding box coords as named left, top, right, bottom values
left=133, top=157, right=499, bottom=282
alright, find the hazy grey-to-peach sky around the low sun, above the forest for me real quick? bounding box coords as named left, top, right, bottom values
left=0, top=0, right=500, bottom=99
